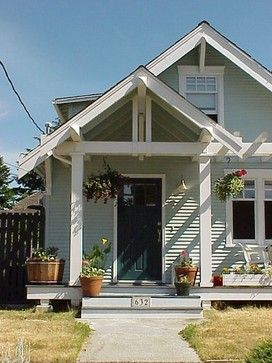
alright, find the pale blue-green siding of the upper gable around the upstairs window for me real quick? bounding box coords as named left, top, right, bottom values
left=159, top=46, right=272, bottom=141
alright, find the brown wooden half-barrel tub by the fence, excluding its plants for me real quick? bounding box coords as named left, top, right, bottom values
left=26, top=260, right=65, bottom=284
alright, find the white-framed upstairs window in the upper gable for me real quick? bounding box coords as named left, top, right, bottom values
left=178, top=66, right=224, bottom=125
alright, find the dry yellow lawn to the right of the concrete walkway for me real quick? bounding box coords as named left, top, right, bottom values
left=181, top=307, right=272, bottom=361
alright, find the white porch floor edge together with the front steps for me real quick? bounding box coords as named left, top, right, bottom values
left=27, top=283, right=272, bottom=318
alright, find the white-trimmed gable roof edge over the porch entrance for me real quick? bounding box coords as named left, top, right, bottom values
left=19, top=66, right=242, bottom=177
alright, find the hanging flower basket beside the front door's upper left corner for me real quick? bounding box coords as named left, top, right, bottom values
left=83, top=164, right=129, bottom=204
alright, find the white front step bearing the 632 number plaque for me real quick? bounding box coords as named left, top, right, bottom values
left=81, top=293, right=202, bottom=319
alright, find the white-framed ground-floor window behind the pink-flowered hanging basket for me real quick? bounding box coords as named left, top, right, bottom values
left=225, top=169, right=272, bottom=246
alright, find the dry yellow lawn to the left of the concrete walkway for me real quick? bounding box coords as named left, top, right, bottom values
left=0, top=310, right=90, bottom=363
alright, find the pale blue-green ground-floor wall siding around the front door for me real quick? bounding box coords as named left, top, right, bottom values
left=46, top=157, right=272, bottom=281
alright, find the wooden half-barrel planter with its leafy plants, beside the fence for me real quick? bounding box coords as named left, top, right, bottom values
left=26, top=247, right=65, bottom=284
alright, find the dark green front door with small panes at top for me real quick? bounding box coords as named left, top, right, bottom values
left=117, top=179, right=162, bottom=281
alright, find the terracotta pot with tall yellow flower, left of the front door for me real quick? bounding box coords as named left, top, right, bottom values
left=80, top=238, right=111, bottom=297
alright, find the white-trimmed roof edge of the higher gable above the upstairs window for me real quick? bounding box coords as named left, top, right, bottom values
left=146, top=21, right=272, bottom=91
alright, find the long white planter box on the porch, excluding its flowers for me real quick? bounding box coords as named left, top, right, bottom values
left=223, top=274, right=272, bottom=286
